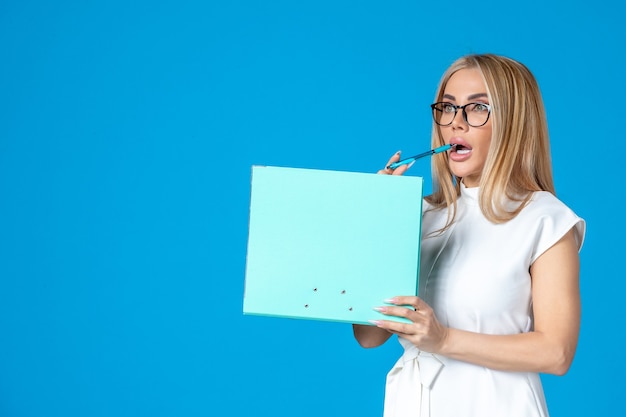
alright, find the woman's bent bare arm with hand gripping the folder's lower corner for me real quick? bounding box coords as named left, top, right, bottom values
left=370, top=230, right=580, bottom=375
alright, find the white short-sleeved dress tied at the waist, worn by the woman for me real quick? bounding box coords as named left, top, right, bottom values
left=384, top=186, right=585, bottom=417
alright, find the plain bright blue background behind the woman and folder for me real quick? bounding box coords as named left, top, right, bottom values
left=0, top=0, right=626, bottom=417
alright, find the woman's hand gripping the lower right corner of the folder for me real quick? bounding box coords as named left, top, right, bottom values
left=373, top=296, right=448, bottom=353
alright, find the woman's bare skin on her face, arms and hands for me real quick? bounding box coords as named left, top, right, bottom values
left=353, top=70, right=581, bottom=375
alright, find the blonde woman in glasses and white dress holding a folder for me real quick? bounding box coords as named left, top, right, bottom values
left=354, top=54, right=585, bottom=417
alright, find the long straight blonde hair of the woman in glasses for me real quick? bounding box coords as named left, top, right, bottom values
left=426, top=54, right=555, bottom=231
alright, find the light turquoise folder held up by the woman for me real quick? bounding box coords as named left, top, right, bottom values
left=243, top=166, right=423, bottom=324
